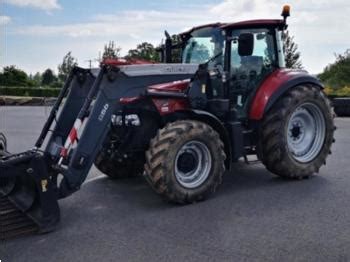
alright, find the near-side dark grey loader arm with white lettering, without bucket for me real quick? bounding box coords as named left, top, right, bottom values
left=59, top=65, right=196, bottom=198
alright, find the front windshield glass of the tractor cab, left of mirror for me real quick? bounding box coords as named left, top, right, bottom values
left=182, top=27, right=224, bottom=64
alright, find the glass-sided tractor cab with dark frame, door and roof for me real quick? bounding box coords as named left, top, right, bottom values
left=164, top=19, right=286, bottom=118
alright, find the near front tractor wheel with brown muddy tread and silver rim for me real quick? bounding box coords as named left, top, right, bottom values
left=144, top=120, right=226, bottom=204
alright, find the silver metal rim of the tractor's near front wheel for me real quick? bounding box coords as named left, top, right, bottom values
left=175, top=141, right=212, bottom=188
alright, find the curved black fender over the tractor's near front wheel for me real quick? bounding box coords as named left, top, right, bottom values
left=163, top=109, right=232, bottom=170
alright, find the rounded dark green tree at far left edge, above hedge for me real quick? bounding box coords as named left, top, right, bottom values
left=0, top=65, right=29, bottom=86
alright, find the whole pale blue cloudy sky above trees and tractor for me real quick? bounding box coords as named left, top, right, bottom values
left=0, top=0, right=350, bottom=74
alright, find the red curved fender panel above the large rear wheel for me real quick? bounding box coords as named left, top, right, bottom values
left=249, top=69, right=306, bottom=120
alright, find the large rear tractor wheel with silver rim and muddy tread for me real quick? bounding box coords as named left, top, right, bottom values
left=260, top=86, right=335, bottom=179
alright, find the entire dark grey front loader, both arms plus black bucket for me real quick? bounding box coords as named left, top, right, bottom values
left=0, top=64, right=197, bottom=238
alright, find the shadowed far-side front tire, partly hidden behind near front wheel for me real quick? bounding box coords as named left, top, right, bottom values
left=95, top=152, right=144, bottom=179
